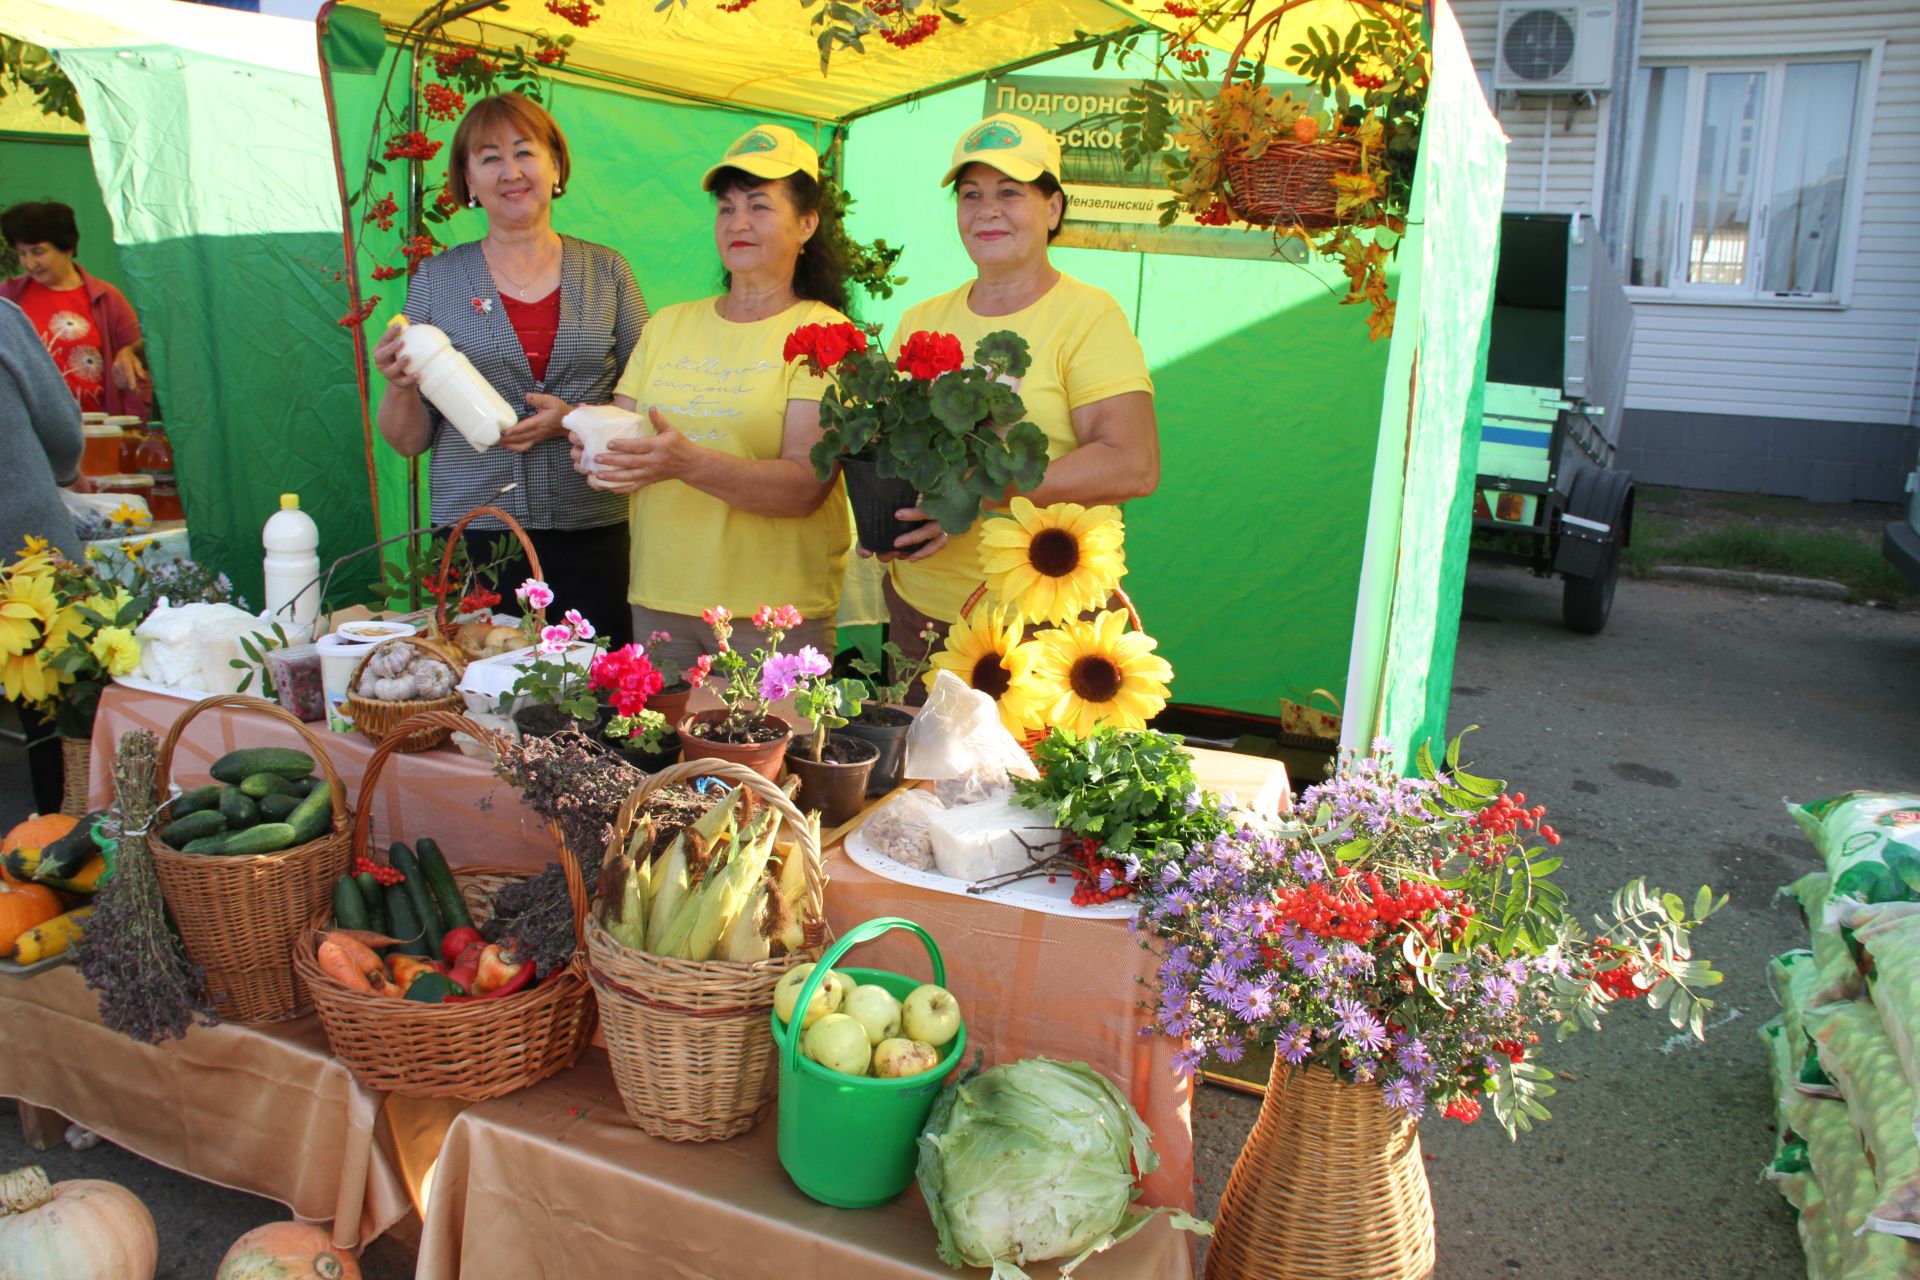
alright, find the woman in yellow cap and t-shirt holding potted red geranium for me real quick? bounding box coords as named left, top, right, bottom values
left=879, top=113, right=1160, bottom=656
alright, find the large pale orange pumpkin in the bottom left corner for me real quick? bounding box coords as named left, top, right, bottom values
left=0, top=1165, right=159, bottom=1280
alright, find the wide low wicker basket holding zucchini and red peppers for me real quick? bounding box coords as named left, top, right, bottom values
left=294, top=712, right=593, bottom=1102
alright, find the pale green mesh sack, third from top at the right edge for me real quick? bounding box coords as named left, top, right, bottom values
left=1805, top=1000, right=1920, bottom=1238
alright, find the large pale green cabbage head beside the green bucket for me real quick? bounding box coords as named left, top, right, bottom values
left=920, top=1057, right=1213, bottom=1280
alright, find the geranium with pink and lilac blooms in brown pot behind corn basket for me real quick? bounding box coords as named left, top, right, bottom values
left=680, top=604, right=806, bottom=781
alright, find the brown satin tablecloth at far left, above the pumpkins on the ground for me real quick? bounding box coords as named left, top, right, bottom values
left=0, top=965, right=413, bottom=1245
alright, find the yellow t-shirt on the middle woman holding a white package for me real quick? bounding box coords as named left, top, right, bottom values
left=614, top=297, right=852, bottom=618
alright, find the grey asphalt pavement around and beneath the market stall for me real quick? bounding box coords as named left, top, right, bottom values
left=0, top=566, right=1920, bottom=1280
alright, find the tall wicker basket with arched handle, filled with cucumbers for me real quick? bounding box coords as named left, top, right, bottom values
left=146, top=693, right=353, bottom=1023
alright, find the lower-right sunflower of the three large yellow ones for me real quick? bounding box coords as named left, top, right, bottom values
left=1031, top=610, right=1173, bottom=737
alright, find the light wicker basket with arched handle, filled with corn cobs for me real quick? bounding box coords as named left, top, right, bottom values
left=588, top=760, right=826, bottom=1142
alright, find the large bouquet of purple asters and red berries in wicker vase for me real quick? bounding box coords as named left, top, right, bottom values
left=1129, top=739, right=1726, bottom=1136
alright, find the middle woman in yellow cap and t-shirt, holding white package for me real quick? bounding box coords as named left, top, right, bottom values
left=574, top=125, right=852, bottom=666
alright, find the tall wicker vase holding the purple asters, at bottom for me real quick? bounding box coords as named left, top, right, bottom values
left=1206, top=1057, right=1434, bottom=1280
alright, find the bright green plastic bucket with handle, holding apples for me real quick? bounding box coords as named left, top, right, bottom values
left=768, top=915, right=966, bottom=1209
